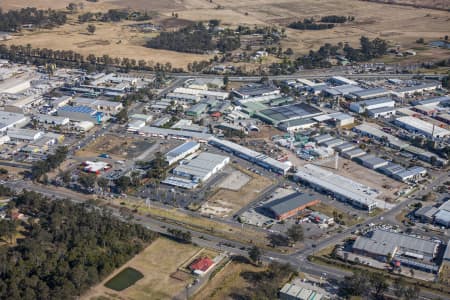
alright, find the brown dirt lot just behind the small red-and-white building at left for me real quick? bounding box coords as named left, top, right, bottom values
left=76, top=135, right=152, bottom=159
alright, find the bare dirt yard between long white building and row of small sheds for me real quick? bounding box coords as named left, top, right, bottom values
left=315, top=158, right=407, bottom=202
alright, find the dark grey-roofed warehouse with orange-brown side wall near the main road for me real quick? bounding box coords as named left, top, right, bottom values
left=263, top=192, right=320, bottom=221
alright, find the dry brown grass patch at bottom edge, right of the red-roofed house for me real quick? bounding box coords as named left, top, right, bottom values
left=193, top=262, right=263, bottom=300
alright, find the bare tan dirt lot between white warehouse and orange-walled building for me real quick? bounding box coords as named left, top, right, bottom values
left=199, top=166, right=273, bottom=218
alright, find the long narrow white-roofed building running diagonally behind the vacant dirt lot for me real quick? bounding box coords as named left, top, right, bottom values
left=209, top=137, right=291, bottom=175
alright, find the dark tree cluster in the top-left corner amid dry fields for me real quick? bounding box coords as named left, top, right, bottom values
left=0, top=7, right=67, bottom=32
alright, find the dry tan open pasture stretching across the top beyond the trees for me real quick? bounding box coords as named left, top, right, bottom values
left=0, top=0, right=450, bottom=67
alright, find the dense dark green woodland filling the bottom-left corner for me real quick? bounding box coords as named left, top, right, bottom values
left=0, top=191, right=157, bottom=299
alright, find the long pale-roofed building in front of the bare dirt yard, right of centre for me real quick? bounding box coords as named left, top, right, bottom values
left=294, top=164, right=378, bottom=211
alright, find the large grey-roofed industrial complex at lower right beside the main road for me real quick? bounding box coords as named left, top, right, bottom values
left=352, top=229, right=439, bottom=273
